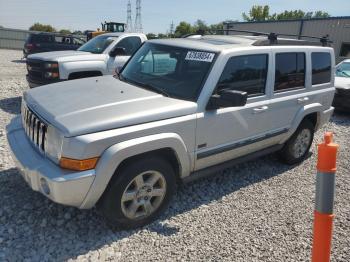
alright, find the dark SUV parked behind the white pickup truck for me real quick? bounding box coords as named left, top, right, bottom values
left=23, top=33, right=86, bottom=57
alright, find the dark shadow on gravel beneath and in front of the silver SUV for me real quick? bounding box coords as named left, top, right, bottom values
left=0, top=156, right=291, bottom=260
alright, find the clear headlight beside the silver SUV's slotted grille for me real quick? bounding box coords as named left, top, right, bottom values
left=45, top=125, right=63, bottom=164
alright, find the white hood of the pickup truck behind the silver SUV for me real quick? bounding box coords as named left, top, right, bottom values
left=28, top=50, right=106, bottom=62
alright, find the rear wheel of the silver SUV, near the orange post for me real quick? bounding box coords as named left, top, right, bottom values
left=279, top=120, right=315, bottom=165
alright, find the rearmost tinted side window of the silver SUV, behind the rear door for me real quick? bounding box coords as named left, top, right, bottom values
left=311, top=53, right=332, bottom=85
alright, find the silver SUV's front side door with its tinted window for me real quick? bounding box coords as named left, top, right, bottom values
left=195, top=52, right=272, bottom=170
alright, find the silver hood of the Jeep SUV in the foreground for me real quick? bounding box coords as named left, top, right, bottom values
left=24, top=76, right=197, bottom=137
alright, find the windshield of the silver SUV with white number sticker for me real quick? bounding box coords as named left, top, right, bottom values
left=119, top=43, right=215, bottom=101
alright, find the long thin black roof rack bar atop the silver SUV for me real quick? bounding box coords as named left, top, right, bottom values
left=215, top=29, right=333, bottom=46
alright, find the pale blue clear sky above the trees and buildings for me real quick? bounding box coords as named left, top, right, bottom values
left=0, top=0, right=350, bottom=33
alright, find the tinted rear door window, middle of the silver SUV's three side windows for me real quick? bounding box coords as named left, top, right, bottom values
left=275, top=53, right=305, bottom=92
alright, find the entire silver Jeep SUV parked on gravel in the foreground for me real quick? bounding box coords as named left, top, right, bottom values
left=7, top=36, right=335, bottom=228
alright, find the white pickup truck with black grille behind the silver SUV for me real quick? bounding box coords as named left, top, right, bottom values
left=27, top=33, right=147, bottom=88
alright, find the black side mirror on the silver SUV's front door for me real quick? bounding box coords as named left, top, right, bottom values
left=207, top=89, right=248, bottom=110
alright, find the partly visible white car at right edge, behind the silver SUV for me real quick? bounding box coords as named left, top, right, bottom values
left=333, top=59, right=350, bottom=111
